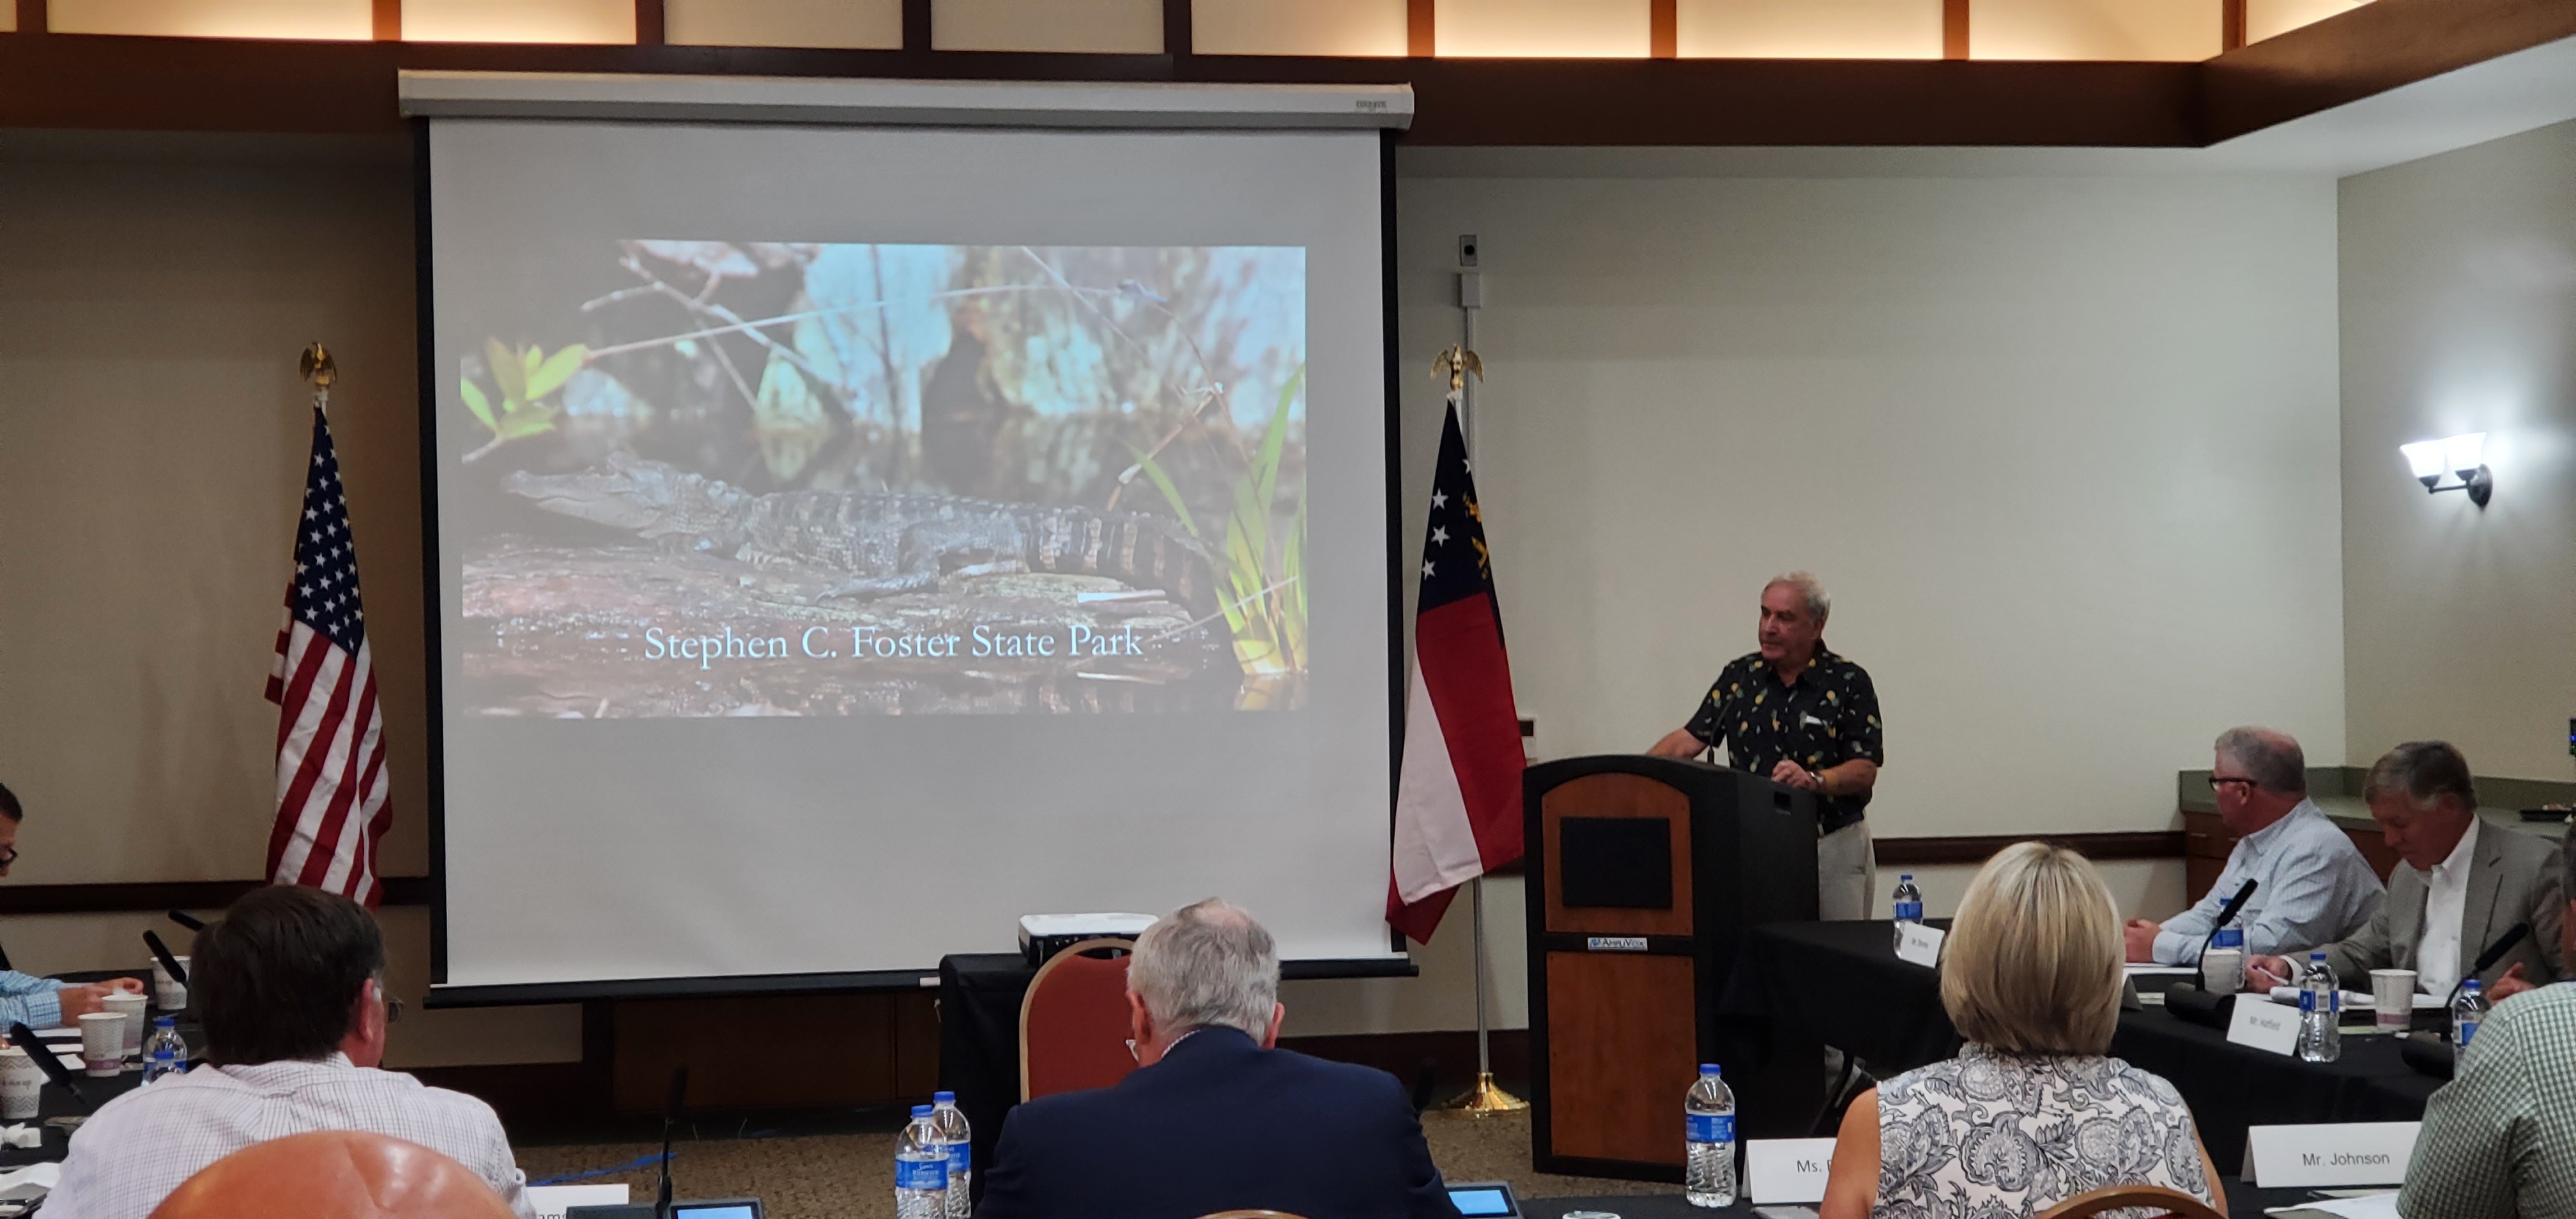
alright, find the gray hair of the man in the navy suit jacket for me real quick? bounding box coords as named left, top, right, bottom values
left=1128, top=897, right=1280, bottom=1039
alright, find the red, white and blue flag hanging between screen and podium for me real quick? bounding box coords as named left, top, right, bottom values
left=1386, top=402, right=1525, bottom=943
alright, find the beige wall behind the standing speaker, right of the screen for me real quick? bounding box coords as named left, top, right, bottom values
left=1399, top=152, right=2344, bottom=835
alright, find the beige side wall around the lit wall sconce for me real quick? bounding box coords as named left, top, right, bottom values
left=2342, top=124, right=2576, bottom=778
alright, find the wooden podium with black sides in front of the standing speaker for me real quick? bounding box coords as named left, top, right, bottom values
left=1522, top=755, right=1824, bottom=1180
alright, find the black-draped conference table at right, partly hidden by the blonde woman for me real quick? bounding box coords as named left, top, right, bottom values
left=1721, top=920, right=2444, bottom=1172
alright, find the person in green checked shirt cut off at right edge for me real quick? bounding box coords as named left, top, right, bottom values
left=2398, top=832, right=2576, bottom=1219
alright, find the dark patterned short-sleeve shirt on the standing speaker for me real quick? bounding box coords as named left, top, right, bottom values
left=1690, top=644, right=1888, bottom=832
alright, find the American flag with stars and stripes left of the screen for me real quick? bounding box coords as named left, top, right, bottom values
left=268, top=404, right=394, bottom=910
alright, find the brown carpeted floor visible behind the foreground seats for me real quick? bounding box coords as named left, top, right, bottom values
left=518, top=1114, right=1675, bottom=1219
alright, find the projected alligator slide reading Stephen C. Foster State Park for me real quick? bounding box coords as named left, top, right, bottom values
left=438, top=240, right=1308, bottom=719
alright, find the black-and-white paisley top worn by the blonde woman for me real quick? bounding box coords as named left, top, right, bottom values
left=1870, top=1044, right=2218, bottom=1219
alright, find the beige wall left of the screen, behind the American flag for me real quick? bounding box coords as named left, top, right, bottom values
left=0, top=137, right=579, bottom=1064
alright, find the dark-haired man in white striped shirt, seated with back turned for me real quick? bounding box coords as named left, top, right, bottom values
left=44, top=887, right=533, bottom=1219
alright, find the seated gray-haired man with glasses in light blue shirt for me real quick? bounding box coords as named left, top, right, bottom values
left=2125, top=727, right=2386, bottom=964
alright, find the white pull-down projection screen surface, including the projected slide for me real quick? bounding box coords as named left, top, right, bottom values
left=430, top=121, right=1391, bottom=987
